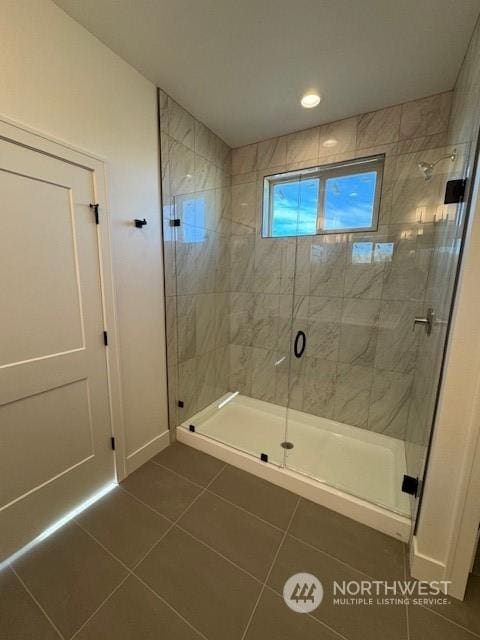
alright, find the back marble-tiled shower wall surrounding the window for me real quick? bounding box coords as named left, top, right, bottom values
left=229, top=92, right=454, bottom=439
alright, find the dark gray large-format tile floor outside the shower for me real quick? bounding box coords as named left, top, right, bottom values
left=0, top=444, right=480, bottom=640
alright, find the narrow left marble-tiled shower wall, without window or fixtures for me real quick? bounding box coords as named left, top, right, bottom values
left=159, top=90, right=231, bottom=427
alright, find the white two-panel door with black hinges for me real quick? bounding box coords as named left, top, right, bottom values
left=0, top=134, right=115, bottom=561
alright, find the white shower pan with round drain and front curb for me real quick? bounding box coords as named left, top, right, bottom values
left=177, top=394, right=411, bottom=541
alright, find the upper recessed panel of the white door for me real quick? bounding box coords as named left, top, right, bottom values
left=0, top=171, right=84, bottom=365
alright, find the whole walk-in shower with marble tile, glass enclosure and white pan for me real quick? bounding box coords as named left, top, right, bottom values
left=160, top=87, right=471, bottom=539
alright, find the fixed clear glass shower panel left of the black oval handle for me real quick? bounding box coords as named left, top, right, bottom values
left=174, top=183, right=295, bottom=465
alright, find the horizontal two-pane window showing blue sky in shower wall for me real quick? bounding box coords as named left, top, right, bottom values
left=263, top=155, right=384, bottom=238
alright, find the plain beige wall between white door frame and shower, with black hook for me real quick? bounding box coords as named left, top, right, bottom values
left=0, top=0, right=167, bottom=470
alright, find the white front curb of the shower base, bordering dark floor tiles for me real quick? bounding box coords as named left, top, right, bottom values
left=177, top=428, right=411, bottom=542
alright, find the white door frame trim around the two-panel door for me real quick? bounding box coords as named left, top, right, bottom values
left=0, top=114, right=127, bottom=482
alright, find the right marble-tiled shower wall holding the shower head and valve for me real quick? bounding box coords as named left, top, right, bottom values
left=406, top=24, right=480, bottom=476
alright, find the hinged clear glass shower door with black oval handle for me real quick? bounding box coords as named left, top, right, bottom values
left=286, top=140, right=468, bottom=520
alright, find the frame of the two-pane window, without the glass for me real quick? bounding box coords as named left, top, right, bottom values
left=261, top=154, right=385, bottom=239
